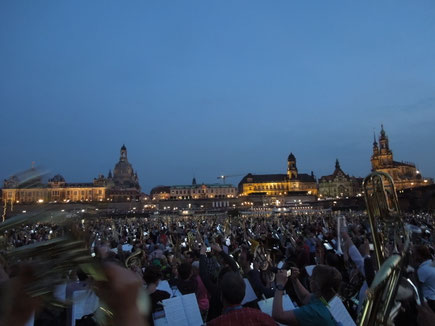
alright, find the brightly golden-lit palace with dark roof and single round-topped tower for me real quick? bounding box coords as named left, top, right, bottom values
left=239, top=153, right=317, bottom=196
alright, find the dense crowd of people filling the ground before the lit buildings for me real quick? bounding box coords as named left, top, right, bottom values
left=0, top=212, right=435, bottom=326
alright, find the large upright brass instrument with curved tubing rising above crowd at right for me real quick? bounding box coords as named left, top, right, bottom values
left=358, top=172, right=418, bottom=326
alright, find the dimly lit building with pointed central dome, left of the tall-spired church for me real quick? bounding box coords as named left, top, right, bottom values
left=319, top=160, right=362, bottom=198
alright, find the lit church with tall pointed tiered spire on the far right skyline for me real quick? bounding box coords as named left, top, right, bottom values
left=371, top=125, right=432, bottom=190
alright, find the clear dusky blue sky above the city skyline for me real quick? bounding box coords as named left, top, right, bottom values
left=0, top=0, right=435, bottom=192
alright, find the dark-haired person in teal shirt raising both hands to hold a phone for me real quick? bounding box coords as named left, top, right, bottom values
left=272, top=265, right=341, bottom=326
